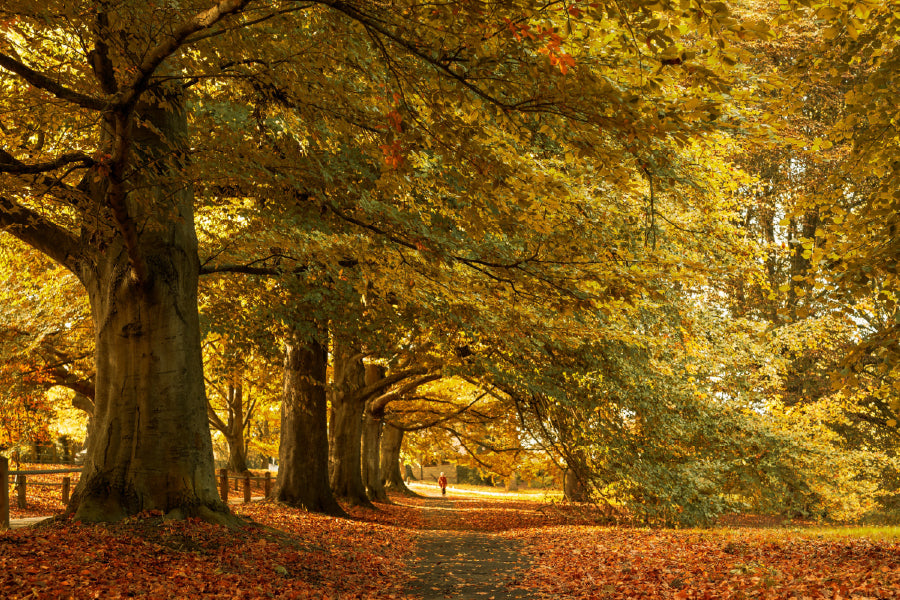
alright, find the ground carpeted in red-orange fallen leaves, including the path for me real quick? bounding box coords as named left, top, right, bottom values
left=0, top=487, right=900, bottom=600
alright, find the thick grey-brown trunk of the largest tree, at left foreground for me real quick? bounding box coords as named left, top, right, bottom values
left=68, top=96, right=233, bottom=522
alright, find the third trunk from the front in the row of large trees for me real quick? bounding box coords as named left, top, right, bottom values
left=331, top=340, right=371, bottom=506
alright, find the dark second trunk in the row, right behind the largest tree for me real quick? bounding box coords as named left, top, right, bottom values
left=275, top=331, right=344, bottom=515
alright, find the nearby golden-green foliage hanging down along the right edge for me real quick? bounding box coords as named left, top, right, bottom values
left=795, top=3, right=900, bottom=427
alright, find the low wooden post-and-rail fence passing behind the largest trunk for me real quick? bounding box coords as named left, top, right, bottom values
left=0, top=456, right=272, bottom=531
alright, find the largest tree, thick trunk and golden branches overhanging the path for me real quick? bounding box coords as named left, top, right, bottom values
left=0, top=0, right=772, bottom=520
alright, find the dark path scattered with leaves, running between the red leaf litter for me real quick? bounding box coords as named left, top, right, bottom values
left=408, top=496, right=535, bottom=600
